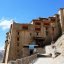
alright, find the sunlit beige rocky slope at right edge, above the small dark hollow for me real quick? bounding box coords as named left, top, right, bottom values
left=55, top=35, right=64, bottom=54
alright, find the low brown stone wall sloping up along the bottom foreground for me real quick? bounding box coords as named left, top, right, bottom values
left=8, top=54, right=37, bottom=64
